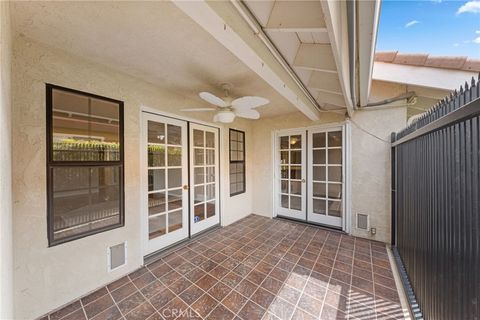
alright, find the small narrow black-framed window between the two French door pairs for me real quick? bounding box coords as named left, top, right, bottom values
left=230, top=129, right=246, bottom=196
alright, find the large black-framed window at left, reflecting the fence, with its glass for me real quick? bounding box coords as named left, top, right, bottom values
left=46, top=84, right=125, bottom=246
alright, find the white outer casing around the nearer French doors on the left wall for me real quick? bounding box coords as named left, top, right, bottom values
left=137, top=105, right=224, bottom=257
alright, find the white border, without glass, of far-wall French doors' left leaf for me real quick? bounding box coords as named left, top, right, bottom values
left=274, top=129, right=307, bottom=220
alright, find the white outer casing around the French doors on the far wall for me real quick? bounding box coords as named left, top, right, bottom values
left=272, top=120, right=352, bottom=233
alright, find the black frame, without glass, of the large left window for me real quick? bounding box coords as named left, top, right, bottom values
left=45, top=83, right=125, bottom=247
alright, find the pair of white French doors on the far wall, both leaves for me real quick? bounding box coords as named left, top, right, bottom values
left=275, top=125, right=346, bottom=228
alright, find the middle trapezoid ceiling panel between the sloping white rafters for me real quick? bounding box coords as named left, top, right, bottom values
left=293, top=44, right=337, bottom=72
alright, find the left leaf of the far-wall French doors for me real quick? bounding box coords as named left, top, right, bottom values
left=276, top=130, right=306, bottom=220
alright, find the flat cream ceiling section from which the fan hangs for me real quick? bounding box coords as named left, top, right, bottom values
left=12, top=1, right=297, bottom=117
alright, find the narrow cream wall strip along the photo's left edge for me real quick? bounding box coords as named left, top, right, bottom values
left=0, top=1, right=13, bottom=319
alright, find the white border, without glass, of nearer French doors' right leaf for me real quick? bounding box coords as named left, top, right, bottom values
left=188, top=123, right=220, bottom=236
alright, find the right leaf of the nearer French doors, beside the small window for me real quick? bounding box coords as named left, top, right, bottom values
left=190, top=123, right=220, bottom=235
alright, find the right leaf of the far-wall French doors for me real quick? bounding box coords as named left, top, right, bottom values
left=308, top=126, right=345, bottom=227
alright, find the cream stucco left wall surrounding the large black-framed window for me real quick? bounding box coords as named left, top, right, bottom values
left=11, top=37, right=254, bottom=319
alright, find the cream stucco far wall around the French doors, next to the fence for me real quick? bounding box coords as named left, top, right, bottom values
left=253, top=108, right=406, bottom=243
